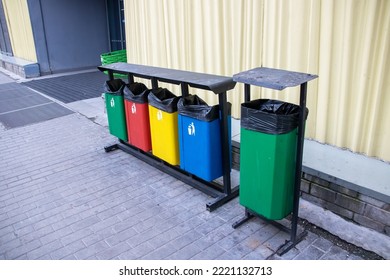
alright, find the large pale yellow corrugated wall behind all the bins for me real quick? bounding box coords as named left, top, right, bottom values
left=125, top=0, right=390, bottom=161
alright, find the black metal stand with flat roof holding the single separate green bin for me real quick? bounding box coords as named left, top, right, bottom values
left=233, top=67, right=318, bottom=255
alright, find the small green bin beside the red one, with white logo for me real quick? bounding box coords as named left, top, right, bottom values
left=104, top=79, right=127, bottom=141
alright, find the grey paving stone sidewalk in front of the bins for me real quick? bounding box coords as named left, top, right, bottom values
left=0, top=109, right=368, bottom=260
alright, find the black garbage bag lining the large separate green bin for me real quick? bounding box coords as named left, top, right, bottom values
left=241, top=99, right=309, bottom=134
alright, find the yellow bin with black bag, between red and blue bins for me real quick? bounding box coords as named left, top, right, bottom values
left=148, top=88, right=180, bottom=165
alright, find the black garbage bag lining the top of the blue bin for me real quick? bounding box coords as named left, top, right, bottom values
left=177, top=95, right=231, bottom=122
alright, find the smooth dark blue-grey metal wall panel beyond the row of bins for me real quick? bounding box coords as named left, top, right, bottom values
left=29, top=0, right=109, bottom=73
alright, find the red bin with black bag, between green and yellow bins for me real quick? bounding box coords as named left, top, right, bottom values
left=123, top=83, right=152, bottom=152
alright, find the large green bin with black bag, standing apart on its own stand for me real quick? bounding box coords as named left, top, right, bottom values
left=239, top=99, right=308, bottom=220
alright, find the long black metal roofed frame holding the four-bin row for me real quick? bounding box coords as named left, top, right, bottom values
left=98, top=62, right=238, bottom=211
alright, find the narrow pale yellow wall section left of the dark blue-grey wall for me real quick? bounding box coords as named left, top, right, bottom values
left=2, top=0, right=37, bottom=62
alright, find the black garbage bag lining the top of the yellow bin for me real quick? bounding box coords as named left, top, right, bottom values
left=148, top=88, right=179, bottom=113
